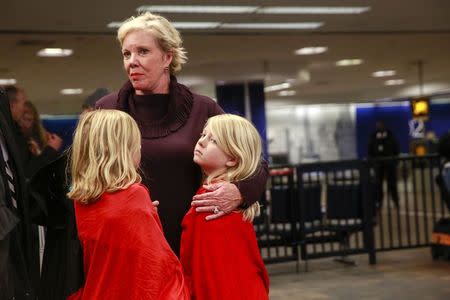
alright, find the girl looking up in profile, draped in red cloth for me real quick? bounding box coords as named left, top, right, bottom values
left=181, top=114, right=269, bottom=300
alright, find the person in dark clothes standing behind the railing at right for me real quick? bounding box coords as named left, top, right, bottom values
left=368, top=121, right=399, bottom=209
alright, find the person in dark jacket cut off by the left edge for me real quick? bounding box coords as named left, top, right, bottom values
left=0, top=89, right=34, bottom=299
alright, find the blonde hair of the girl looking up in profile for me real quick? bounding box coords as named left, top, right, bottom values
left=205, top=114, right=262, bottom=221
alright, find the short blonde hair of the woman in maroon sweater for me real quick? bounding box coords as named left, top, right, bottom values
left=117, top=12, right=187, bottom=74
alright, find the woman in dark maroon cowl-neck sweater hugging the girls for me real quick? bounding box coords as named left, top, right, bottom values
left=96, top=12, right=268, bottom=253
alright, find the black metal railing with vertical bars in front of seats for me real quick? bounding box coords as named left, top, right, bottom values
left=255, top=155, right=449, bottom=264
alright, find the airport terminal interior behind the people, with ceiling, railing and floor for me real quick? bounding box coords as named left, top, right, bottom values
left=0, top=0, right=450, bottom=300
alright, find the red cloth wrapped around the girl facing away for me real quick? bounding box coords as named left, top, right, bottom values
left=69, top=184, right=189, bottom=300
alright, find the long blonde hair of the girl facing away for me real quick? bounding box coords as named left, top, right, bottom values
left=67, top=109, right=141, bottom=204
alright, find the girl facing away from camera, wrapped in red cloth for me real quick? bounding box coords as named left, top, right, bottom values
left=68, top=110, right=189, bottom=300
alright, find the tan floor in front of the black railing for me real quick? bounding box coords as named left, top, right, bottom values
left=267, top=248, right=450, bottom=300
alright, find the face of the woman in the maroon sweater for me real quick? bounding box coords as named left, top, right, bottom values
left=122, top=30, right=172, bottom=95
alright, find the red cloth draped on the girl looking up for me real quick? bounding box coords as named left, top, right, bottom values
left=181, top=188, right=269, bottom=300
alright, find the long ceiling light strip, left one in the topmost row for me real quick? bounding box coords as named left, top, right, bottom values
left=136, top=5, right=258, bottom=14
